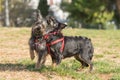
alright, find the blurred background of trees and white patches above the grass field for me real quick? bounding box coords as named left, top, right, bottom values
left=0, top=0, right=120, bottom=29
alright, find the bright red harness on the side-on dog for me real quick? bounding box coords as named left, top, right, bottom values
left=44, top=32, right=65, bottom=53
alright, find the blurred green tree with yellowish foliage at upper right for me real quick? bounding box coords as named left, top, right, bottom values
left=63, top=0, right=114, bottom=28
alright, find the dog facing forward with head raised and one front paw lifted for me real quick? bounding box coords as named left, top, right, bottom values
left=29, top=10, right=47, bottom=68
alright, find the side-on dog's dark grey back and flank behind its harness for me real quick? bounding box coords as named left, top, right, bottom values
left=63, top=36, right=94, bottom=59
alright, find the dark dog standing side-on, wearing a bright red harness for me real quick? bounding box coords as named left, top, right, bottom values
left=44, top=17, right=94, bottom=72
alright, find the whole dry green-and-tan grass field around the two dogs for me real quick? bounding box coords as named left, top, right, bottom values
left=0, top=27, right=120, bottom=80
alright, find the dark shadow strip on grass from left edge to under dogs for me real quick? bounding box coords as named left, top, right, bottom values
left=0, top=63, right=53, bottom=72
